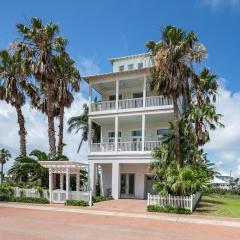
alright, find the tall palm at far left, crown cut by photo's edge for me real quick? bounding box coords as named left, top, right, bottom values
left=0, top=50, right=32, bottom=156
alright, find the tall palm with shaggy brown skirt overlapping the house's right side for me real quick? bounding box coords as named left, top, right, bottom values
left=146, top=26, right=206, bottom=165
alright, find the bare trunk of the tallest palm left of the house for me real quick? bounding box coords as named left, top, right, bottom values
left=46, top=81, right=56, bottom=161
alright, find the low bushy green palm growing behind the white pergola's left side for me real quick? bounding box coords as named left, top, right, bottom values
left=8, top=150, right=68, bottom=187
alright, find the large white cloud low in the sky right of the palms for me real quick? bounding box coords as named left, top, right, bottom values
left=205, top=87, right=240, bottom=176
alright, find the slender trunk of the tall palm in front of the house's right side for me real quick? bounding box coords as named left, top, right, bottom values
left=173, top=97, right=181, bottom=165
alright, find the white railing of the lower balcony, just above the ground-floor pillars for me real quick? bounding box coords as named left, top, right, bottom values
left=90, top=141, right=161, bottom=152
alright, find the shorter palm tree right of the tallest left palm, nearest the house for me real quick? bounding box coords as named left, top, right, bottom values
left=55, top=53, right=80, bottom=155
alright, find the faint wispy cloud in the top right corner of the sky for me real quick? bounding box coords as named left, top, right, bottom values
left=197, top=0, right=240, bottom=11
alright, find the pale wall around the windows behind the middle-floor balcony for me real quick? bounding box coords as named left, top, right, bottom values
left=102, top=120, right=168, bottom=142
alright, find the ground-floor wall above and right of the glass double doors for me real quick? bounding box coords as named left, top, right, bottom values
left=120, top=164, right=149, bottom=199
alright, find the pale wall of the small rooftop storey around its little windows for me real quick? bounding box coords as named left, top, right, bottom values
left=113, top=56, right=152, bottom=72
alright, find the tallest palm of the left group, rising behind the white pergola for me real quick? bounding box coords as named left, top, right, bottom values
left=16, top=18, right=67, bottom=160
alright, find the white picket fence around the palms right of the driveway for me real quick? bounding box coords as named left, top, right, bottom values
left=147, top=192, right=202, bottom=211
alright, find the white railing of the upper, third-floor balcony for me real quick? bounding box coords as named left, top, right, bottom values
left=91, top=96, right=172, bottom=112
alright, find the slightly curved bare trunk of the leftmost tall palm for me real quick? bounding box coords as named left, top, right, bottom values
left=15, top=105, right=27, bottom=157
